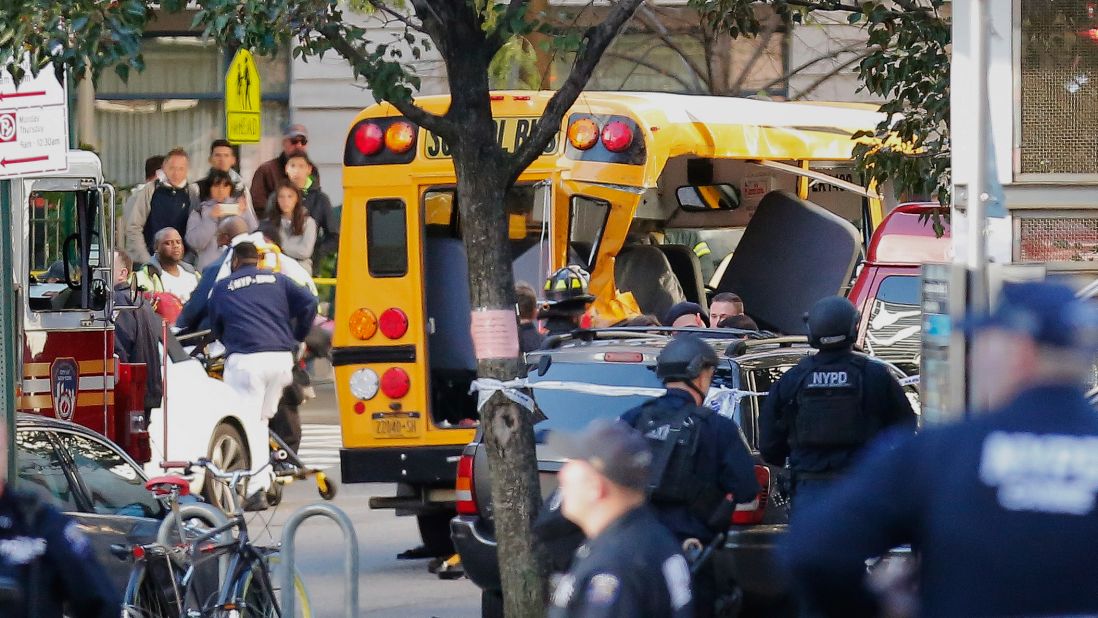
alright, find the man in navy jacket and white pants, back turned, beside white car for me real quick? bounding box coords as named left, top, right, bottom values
left=209, top=243, right=316, bottom=510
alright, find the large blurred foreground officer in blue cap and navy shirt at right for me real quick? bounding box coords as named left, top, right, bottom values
left=783, top=282, right=1098, bottom=616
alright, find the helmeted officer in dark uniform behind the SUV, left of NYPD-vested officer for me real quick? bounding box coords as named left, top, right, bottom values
left=621, top=335, right=759, bottom=616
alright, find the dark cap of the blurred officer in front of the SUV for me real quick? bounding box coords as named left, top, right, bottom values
left=549, top=419, right=652, bottom=492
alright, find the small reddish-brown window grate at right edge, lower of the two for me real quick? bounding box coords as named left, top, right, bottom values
left=1018, top=216, right=1098, bottom=262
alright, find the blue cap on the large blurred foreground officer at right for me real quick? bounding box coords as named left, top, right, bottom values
left=961, top=281, right=1098, bottom=351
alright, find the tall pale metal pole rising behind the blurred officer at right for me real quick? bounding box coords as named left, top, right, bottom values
left=965, top=0, right=994, bottom=409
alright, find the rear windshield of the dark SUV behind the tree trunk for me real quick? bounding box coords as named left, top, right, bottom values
left=529, top=362, right=663, bottom=442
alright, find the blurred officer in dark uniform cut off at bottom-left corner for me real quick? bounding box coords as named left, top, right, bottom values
left=0, top=423, right=122, bottom=618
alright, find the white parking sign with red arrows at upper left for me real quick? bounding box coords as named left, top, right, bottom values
left=0, top=68, right=68, bottom=178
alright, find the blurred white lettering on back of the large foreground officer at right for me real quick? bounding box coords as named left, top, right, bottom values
left=979, top=431, right=1098, bottom=515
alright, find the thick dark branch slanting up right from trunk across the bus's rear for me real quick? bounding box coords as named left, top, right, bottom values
left=507, top=0, right=643, bottom=181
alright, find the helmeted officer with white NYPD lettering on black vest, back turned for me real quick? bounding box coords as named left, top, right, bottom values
left=759, top=296, right=915, bottom=510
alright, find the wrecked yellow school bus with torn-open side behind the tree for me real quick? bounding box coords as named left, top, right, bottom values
left=332, top=91, right=881, bottom=549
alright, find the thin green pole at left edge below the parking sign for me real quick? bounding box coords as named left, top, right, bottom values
left=0, top=180, right=19, bottom=483
